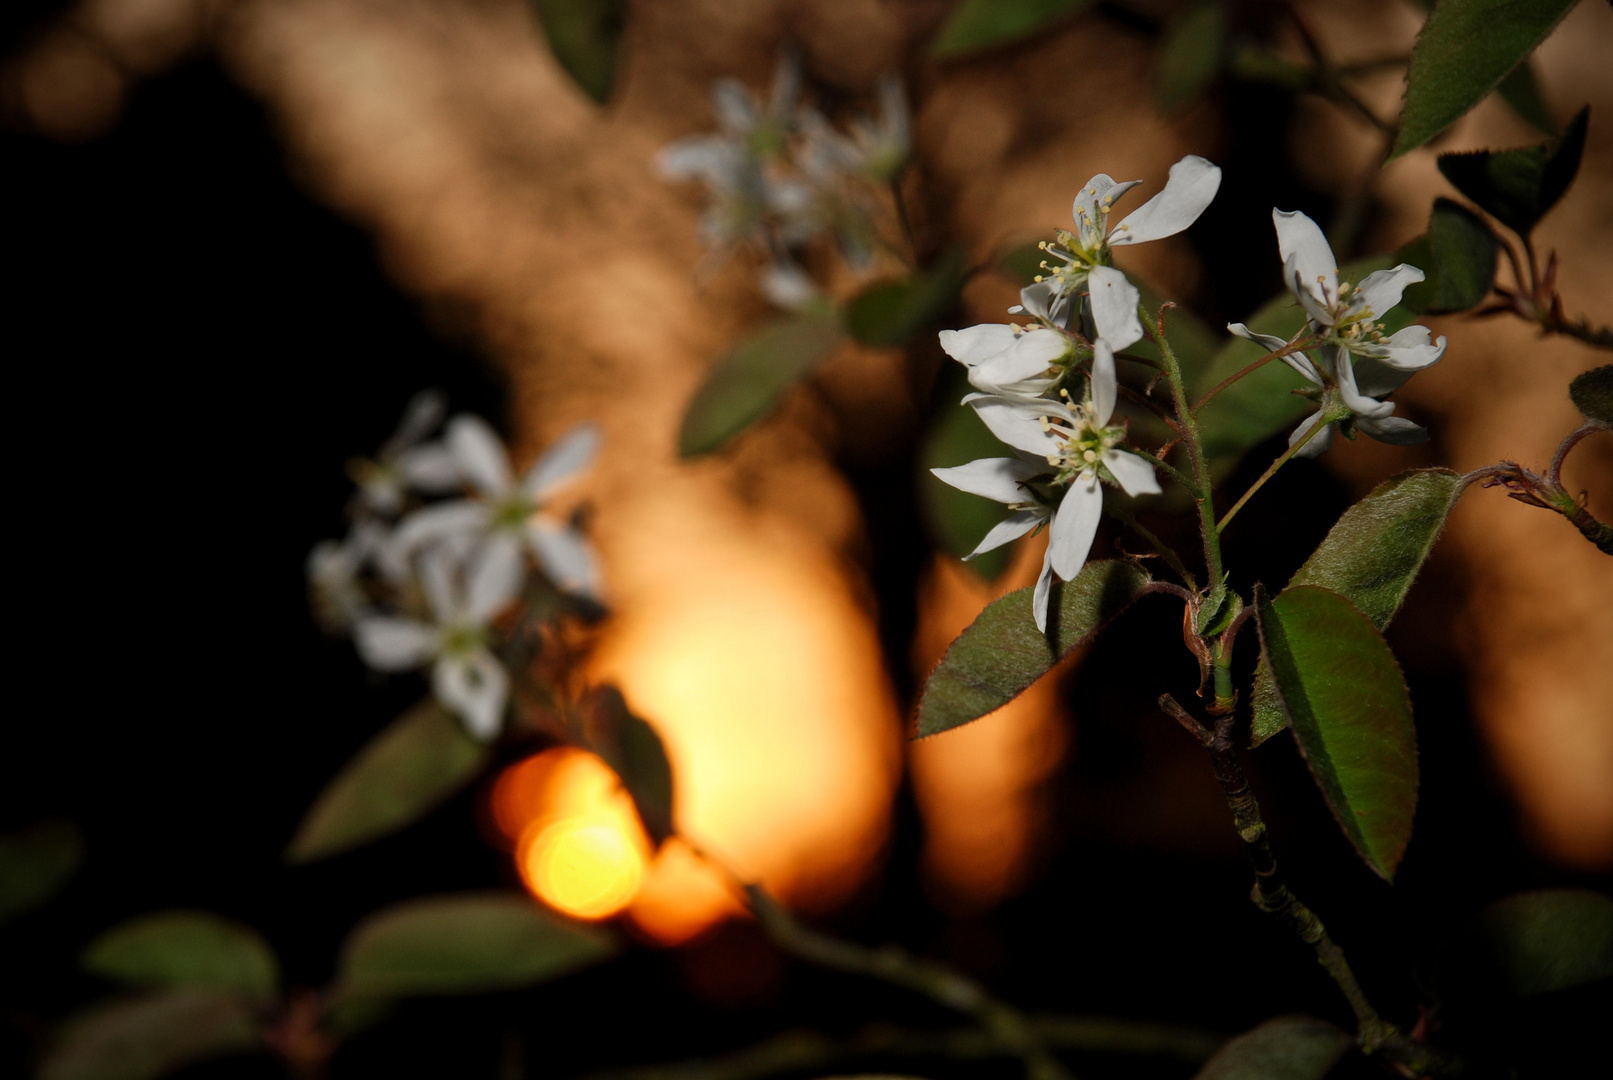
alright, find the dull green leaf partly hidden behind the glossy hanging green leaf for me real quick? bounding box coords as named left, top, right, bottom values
left=1250, top=469, right=1461, bottom=746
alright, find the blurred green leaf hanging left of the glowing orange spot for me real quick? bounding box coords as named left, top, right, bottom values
left=286, top=701, right=490, bottom=862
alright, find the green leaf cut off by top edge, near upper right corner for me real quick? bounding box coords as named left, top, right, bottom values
left=1389, top=0, right=1576, bottom=161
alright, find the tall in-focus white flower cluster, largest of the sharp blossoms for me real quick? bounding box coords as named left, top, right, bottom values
left=934, top=156, right=1221, bottom=630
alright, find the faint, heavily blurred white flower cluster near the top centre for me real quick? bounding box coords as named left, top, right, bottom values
left=660, top=56, right=911, bottom=309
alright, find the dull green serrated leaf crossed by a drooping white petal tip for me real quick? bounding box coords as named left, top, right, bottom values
left=918, top=561, right=1148, bottom=738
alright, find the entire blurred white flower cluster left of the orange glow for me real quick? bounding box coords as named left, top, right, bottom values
left=308, top=392, right=598, bottom=740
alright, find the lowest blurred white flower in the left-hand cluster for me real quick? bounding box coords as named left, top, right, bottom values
left=353, top=548, right=519, bottom=740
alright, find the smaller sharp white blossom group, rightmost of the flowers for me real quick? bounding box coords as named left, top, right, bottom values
left=1226, top=210, right=1445, bottom=458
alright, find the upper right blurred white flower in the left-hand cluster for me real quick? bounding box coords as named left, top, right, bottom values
left=386, top=416, right=600, bottom=598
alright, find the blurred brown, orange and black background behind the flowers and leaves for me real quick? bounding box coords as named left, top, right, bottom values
left=0, top=0, right=1613, bottom=1077
